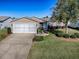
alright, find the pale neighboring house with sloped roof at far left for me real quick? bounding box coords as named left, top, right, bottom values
left=0, top=16, right=12, bottom=29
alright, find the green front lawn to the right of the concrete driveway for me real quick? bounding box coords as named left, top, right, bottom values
left=28, top=34, right=79, bottom=59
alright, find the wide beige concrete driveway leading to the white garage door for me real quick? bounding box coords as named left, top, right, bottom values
left=0, top=34, right=34, bottom=59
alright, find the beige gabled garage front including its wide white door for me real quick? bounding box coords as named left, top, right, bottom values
left=11, top=17, right=39, bottom=33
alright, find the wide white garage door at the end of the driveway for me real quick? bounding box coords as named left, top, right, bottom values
left=12, top=23, right=37, bottom=33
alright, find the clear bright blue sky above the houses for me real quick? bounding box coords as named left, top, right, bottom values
left=0, top=0, right=57, bottom=17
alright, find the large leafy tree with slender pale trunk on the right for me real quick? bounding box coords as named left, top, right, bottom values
left=51, top=0, right=79, bottom=33
